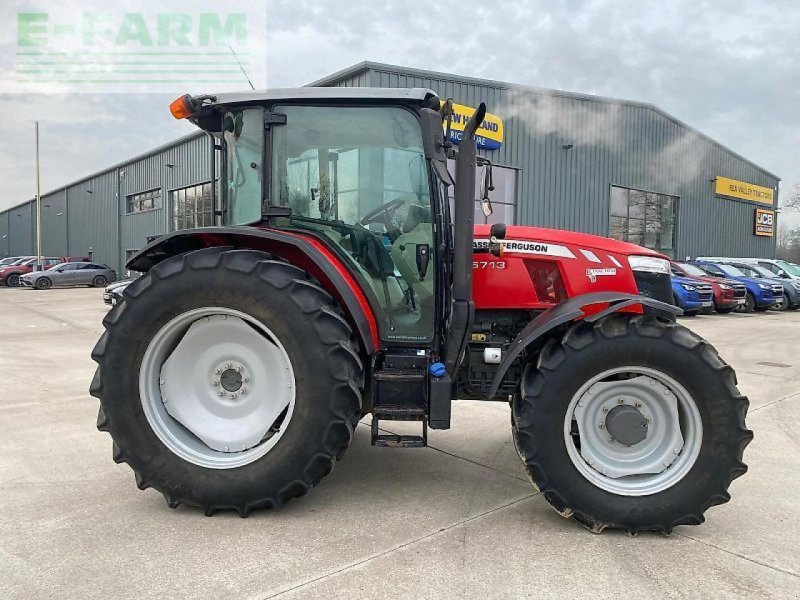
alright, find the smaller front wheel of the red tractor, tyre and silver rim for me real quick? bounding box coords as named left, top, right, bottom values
left=512, top=315, right=752, bottom=534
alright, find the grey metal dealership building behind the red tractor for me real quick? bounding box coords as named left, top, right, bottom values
left=0, top=62, right=780, bottom=270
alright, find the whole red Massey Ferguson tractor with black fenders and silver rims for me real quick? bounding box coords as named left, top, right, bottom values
left=91, top=88, right=752, bottom=534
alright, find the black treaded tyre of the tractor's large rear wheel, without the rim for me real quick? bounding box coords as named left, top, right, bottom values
left=90, top=248, right=364, bottom=517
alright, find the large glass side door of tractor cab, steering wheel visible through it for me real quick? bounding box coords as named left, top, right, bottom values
left=270, top=106, right=436, bottom=341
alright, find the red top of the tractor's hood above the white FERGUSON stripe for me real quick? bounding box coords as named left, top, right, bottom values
left=475, top=225, right=668, bottom=259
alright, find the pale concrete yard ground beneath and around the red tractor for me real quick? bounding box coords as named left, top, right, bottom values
left=0, top=289, right=800, bottom=599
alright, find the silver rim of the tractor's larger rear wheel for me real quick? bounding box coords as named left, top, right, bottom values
left=139, top=307, right=295, bottom=469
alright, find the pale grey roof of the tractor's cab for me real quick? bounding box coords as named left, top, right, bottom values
left=203, top=87, right=436, bottom=105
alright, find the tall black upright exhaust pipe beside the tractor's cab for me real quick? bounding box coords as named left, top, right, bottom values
left=445, top=102, right=486, bottom=377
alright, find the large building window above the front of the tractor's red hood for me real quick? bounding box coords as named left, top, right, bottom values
left=609, top=186, right=678, bottom=256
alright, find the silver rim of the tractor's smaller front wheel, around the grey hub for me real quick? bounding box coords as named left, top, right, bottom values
left=564, top=367, right=703, bottom=496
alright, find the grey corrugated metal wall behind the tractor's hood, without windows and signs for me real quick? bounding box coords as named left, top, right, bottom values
left=318, top=63, right=778, bottom=257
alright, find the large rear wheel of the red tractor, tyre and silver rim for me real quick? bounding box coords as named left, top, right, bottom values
left=91, top=249, right=363, bottom=516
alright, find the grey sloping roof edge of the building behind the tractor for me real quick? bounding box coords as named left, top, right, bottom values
left=308, top=61, right=781, bottom=181
